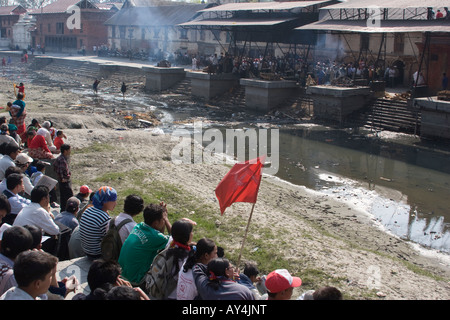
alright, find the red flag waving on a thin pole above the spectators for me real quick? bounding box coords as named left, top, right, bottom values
left=216, top=156, right=266, bottom=215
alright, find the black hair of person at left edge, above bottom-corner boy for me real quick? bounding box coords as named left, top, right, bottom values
left=0, top=226, right=33, bottom=260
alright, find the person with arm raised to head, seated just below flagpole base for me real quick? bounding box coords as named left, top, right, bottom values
left=192, top=258, right=255, bottom=300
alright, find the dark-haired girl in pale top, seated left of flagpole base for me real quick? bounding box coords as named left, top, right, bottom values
left=177, top=238, right=217, bottom=300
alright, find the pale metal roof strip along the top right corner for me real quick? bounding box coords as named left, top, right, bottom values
left=326, top=0, right=450, bottom=9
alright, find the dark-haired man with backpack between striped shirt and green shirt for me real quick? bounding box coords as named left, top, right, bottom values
left=102, top=194, right=144, bottom=261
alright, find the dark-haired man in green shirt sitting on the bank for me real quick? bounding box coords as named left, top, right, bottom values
left=119, top=203, right=172, bottom=285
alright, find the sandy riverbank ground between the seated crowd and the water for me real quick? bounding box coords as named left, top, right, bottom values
left=0, top=63, right=450, bottom=300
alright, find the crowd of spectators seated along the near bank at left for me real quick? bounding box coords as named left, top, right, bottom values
left=0, top=84, right=342, bottom=300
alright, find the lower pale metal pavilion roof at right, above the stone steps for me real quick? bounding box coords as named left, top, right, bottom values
left=296, top=20, right=450, bottom=33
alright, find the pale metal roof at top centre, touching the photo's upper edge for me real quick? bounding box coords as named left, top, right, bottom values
left=201, top=0, right=330, bottom=12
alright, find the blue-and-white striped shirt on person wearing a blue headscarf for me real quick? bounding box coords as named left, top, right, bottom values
left=79, top=207, right=111, bottom=256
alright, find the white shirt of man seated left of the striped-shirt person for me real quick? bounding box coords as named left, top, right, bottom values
left=13, top=202, right=59, bottom=235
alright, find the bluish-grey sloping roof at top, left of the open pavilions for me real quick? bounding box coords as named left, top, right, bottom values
left=105, top=3, right=206, bottom=26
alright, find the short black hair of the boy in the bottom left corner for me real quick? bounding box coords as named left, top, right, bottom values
left=14, top=250, right=58, bottom=287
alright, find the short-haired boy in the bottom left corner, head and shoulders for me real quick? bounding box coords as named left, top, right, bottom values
left=0, top=250, right=58, bottom=300
